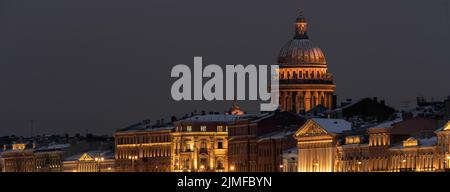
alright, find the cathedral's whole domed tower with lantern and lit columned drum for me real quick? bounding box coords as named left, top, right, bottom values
left=278, top=13, right=335, bottom=113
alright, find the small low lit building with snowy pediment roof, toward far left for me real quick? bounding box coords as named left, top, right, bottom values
left=63, top=151, right=115, bottom=172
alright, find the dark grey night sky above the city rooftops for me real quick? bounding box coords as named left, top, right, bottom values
left=0, top=0, right=450, bottom=135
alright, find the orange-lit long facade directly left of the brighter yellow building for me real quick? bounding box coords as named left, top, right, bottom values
left=115, top=120, right=174, bottom=172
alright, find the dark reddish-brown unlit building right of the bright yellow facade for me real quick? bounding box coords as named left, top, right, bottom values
left=228, top=111, right=306, bottom=172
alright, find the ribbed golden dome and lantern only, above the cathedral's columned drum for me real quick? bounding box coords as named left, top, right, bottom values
left=278, top=15, right=326, bottom=66
